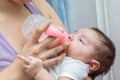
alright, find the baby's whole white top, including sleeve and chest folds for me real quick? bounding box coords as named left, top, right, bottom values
left=49, top=57, right=89, bottom=80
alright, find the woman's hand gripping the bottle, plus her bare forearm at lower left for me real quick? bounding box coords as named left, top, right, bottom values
left=0, top=20, right=65, bottom=80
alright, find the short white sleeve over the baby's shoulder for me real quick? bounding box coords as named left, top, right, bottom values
left=59, top=57, right=88, bottom=80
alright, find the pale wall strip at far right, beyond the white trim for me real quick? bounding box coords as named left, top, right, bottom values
left=106, top=0, right=120, bottom=80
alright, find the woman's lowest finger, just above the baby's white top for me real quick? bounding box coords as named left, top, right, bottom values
left=44, top=53, right=66, bottom=68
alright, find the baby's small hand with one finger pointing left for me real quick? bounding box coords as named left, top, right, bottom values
left=17, top=55, right=43, bottom=78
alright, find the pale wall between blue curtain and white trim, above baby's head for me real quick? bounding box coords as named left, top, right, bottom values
left=66, top=0, right=97, bottom=32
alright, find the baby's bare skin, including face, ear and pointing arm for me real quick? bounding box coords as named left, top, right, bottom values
left=18, top=28, right=100, bottom=80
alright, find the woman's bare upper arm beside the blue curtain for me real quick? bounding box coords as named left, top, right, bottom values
left=32, top=0, right=65, bottom=29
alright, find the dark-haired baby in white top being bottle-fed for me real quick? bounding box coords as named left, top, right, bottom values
left=18, top=28, right=115, bottom=80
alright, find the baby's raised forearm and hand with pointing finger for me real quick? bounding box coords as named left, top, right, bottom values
left=17, top=55, right=54, bottom=80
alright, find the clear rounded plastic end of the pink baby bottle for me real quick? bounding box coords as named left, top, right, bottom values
left=22, top=14, right=46, bottom=39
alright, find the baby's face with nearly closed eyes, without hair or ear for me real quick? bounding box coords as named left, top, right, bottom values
left=67, top=28, right=100, bottom=63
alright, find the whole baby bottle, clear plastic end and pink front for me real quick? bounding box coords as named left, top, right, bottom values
left=22, top=14, right=68, bottom=46
